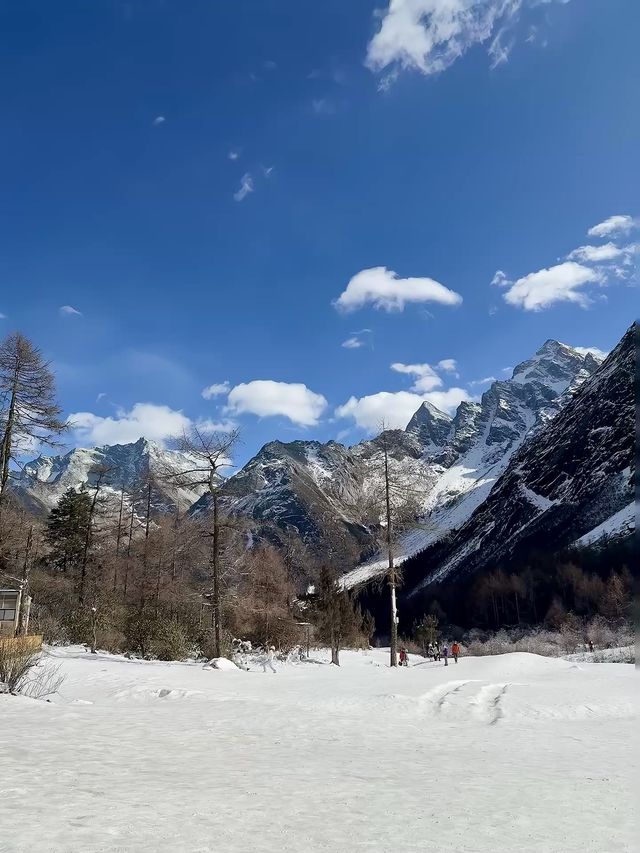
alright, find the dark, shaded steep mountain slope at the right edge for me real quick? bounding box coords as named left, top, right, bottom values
left=403, top=326, right=637, bottom=609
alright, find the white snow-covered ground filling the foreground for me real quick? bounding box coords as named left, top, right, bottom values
left=0, top=648, right=640, bottom=853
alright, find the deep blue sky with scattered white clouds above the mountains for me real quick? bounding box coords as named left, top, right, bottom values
left=0, top=0, right=640, bottom=461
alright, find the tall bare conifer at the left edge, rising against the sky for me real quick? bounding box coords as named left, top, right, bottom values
left=0, top=332, right=67, bottom=502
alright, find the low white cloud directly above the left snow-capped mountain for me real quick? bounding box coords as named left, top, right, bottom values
left=69, top=403, right=191, bottom=446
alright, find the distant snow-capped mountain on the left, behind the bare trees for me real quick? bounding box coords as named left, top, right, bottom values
left=13, top=438, right=208, bottom=511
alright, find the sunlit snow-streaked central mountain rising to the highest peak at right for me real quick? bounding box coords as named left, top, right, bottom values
left=194, top=341, right=599, bottom=564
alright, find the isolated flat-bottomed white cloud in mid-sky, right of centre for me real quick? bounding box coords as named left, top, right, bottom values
left=334, top=267, right=462, bottom=311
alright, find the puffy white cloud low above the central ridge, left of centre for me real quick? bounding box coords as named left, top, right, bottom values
left=227, top=379, right=327, bottom=426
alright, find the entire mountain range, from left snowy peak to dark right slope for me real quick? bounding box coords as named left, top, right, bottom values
left=14, top=329, right=634, bottom=597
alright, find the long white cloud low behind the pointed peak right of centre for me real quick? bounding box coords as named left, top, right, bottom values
left=335, top=388, right=470, bottom=434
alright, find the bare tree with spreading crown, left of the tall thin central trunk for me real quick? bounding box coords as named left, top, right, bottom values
left=169, top=425, right=240, bottom=657
